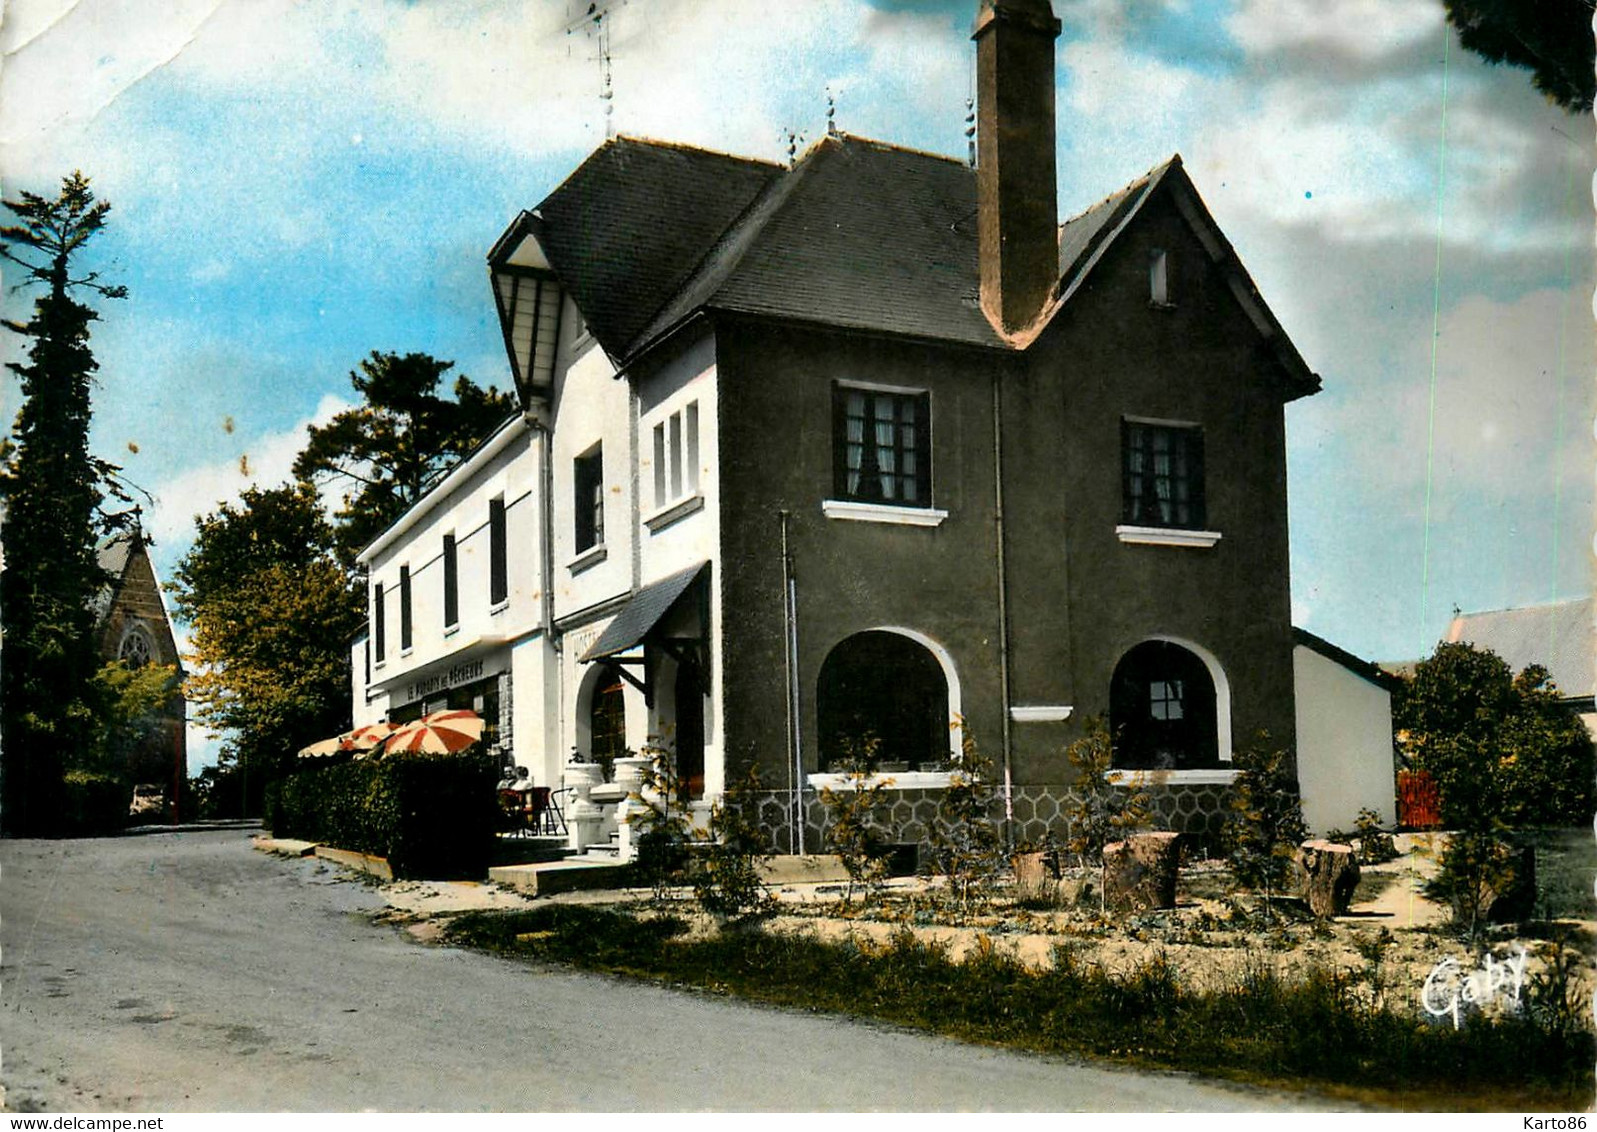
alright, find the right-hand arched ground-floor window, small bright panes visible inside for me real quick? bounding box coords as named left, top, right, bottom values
left=1110, top=640, right=1220, bottom=770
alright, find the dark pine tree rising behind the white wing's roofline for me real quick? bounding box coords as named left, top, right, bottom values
left=294, top=350, right=516, bottom=565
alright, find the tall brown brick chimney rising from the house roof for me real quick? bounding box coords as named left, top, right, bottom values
left=971, top=0, right=1059, bottom=332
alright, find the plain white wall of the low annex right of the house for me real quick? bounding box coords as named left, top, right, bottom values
left=1292, top=642, right=1397, bottom=835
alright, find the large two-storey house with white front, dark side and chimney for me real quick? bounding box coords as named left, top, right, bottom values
left=353, top=0, right=1319, bottom=849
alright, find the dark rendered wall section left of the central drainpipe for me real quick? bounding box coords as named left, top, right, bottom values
left=717, top=323, right=1000, bottom=811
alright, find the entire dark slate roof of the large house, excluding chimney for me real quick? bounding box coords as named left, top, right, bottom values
left=520, top=134, right=1319, bottom=399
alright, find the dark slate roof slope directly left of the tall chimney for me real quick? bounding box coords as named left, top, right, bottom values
left=640, top=134, right=1003, bottom=346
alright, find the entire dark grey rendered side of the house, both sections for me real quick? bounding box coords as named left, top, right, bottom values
left=717, top=185, right=1294, bottom=849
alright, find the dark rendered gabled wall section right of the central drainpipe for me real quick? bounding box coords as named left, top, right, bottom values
left=1005, top=193, right=1294, bottom=795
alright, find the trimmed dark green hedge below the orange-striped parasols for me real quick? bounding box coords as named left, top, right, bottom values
left=267, top=754, right=500, bottom=878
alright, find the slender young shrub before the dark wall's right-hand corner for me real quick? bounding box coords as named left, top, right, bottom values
left=1225, top=731, right=1308, bottom=915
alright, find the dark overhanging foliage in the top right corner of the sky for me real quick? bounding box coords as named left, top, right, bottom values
left=1442, top=0, right=1597, bottom=113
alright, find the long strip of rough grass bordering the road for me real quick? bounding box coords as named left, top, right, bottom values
left=447, top=905, right=1597, bottom=1110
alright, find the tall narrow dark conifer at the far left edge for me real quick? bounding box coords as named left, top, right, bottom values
left=0, top=172, right=126, bottom=833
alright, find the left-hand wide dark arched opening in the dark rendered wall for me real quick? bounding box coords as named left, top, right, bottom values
left=816, top=629, right=950, bottom=771
